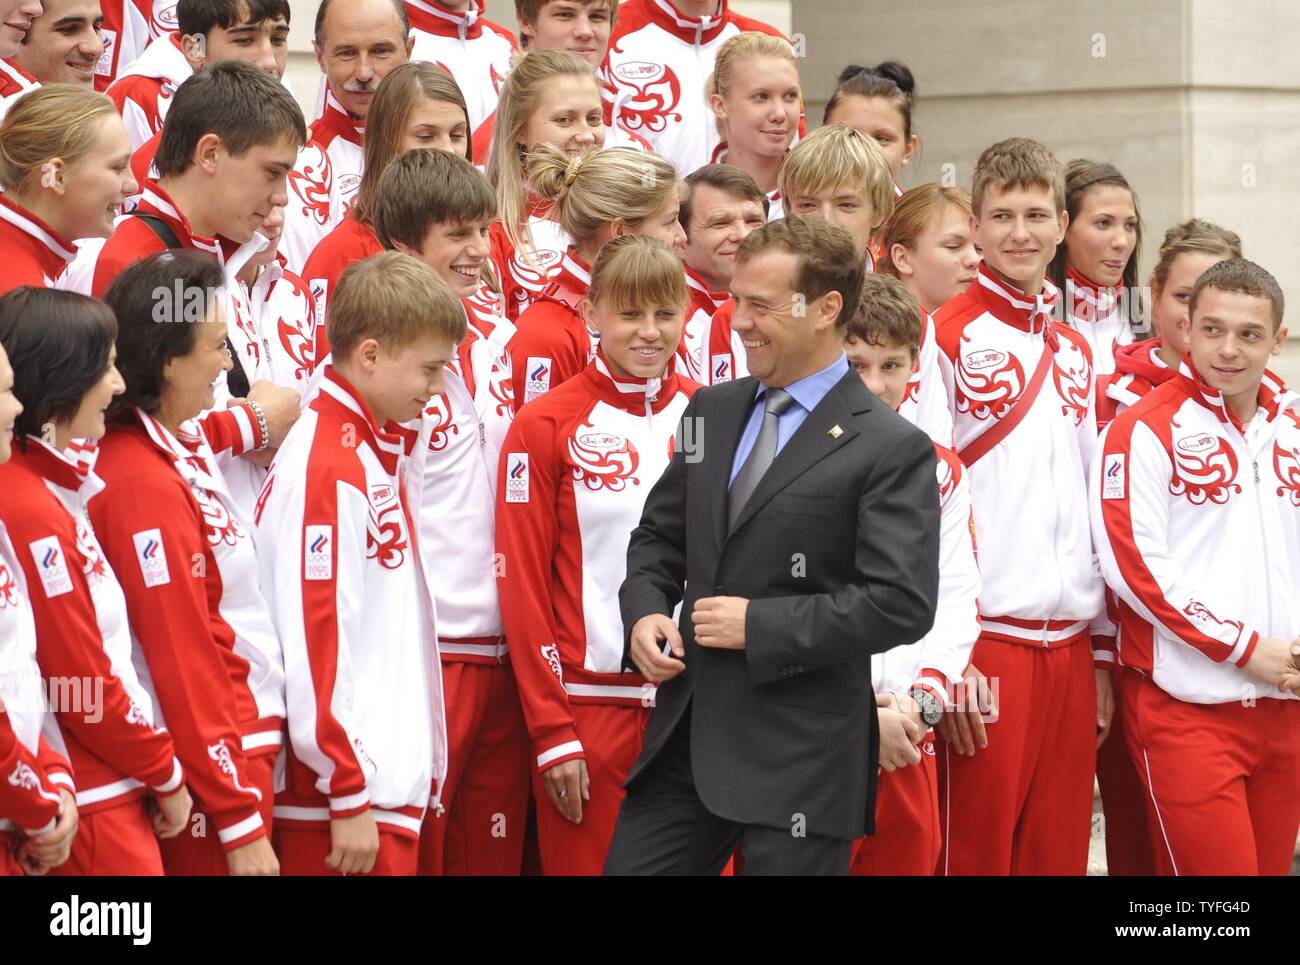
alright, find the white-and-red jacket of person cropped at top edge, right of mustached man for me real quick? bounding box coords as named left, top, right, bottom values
left=406, top=0, right=519, bottom=164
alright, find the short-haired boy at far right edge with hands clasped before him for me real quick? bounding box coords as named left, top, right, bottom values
left=1089, top=259, right=1300, bottom=875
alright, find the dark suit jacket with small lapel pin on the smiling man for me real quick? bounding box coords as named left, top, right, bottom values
left=619, top=367, right=939, bottom=838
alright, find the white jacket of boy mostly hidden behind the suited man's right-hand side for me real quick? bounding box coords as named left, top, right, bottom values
left=871, top=445, right=980, bottom=707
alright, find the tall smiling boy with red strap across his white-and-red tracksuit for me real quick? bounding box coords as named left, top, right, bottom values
left=935, top=138, right=1110, bottom=874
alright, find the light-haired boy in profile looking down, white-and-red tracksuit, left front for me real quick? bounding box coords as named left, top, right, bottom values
left=256, top=252, right=465, bottom=875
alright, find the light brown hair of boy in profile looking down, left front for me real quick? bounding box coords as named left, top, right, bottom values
left=325, top=253, right=468, bottom=359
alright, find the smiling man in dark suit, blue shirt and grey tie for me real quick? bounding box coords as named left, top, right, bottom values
left=605, top=216, right=939, bottom=874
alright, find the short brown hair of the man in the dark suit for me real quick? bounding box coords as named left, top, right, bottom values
left=736, top=215, right=866, bottom=325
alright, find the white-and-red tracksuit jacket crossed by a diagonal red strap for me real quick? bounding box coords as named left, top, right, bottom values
left=935, top=263, right=1113, bottom=646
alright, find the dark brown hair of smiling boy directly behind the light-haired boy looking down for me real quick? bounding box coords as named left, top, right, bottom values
left=372, top=147, right=497, bottom=251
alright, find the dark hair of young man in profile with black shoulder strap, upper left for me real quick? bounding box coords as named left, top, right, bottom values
left=153, top=60, right=307, bottom=178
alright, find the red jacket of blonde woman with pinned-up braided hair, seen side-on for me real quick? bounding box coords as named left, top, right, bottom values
left=510, top=248, right=597, bottom=412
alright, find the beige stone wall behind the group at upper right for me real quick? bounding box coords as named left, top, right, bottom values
left=793, top=0, right=1300, bottom=334
